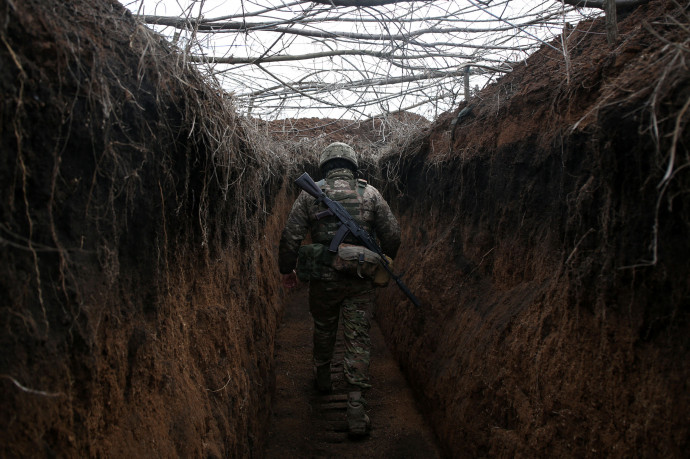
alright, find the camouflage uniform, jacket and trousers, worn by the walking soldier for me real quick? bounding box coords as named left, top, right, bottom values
left=278, top=169, right=400, bottom=389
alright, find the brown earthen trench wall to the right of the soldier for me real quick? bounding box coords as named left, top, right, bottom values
left=378, top=1, right=690, bottom=457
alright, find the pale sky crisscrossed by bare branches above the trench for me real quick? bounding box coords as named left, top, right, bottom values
left=128, top=0, right=596, bottom=118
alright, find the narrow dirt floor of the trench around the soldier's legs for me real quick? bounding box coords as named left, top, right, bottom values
left=266, top=287, right=441, bottom=458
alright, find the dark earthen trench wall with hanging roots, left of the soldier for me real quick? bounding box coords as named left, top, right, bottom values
left=0, top=0, right=289, bottom=457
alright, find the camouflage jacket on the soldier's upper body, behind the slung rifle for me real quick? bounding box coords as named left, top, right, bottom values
left=278, top=169, right=400, bottom=274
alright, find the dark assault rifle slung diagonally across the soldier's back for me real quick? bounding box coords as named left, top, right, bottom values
left=295, top=172, right=421, bottom=307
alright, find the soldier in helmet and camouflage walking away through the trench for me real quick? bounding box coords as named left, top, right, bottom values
left=278, top=142, right=400, bottom=436
